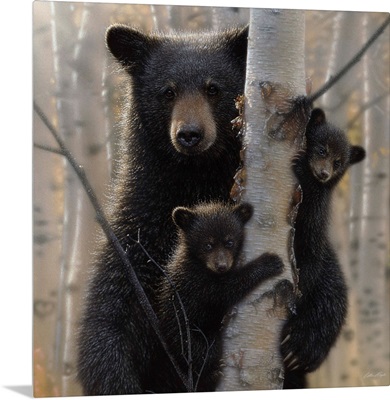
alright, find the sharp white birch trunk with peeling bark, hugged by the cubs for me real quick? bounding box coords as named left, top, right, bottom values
left=219, top=9, right=307, bottom=390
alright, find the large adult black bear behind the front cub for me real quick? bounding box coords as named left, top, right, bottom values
left=77, top=25, right=248, bottom=395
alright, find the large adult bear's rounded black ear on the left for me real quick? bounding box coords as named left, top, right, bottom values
left=106, top=24, right=157, bottom=72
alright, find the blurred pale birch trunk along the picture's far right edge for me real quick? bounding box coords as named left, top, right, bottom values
left=357, top=16, right=390, bottom=386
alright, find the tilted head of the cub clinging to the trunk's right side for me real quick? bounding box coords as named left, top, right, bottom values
left=306, top=109, right=365, bottom=183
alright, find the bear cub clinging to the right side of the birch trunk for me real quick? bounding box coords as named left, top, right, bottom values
left=281, top=108, right=365, bottom=388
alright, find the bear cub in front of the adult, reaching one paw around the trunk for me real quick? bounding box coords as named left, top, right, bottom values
left=151, top=203, right=283, bottom=392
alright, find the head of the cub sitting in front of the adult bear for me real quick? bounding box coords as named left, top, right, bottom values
left=172, top=203, right=253, bottom=274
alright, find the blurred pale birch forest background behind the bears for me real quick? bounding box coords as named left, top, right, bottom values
left=33, top=1, right=390, bottom=397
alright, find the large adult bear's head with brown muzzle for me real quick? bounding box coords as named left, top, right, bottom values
left=107, top=25, right=248, bottom=156
